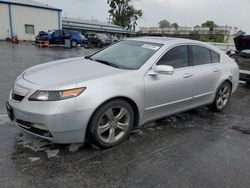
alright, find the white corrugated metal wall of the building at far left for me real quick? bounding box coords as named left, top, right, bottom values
left=0, top=3, right=61, bottom=41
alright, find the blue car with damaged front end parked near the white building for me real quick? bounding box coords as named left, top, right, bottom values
left=36, top=30, right=88, bottom=47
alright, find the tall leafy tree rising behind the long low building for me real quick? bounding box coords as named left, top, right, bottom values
left=107, top=0, right=143, bottom=30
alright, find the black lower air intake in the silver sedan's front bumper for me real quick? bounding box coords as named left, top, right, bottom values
left=16, top=119, right=52, bottom=138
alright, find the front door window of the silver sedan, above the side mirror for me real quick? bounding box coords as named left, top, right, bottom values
left=157, top=46, right=188, bottom=68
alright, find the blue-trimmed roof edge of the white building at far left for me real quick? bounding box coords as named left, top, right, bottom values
left=0, top=0, right=62, bottom=11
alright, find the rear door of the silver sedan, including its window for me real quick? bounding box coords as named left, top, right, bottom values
left=189, top=45, right=222, bottom=107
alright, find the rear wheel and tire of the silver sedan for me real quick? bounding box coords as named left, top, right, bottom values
left=209, top=81, right=232, bottom=112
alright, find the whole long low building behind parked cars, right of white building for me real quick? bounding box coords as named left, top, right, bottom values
left=62, top=17, right=135, bottom=38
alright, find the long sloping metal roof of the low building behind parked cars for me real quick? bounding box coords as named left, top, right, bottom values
left=62, top=17, right=133, bottom=33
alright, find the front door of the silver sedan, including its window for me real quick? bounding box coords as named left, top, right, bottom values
left=144, top=45, right=193, bottom=121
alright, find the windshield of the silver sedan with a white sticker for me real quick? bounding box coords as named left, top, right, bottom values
left=91, top=41, right=162, bottom=70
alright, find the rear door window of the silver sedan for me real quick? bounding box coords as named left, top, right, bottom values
left=191, top=46, right=211, bottom=66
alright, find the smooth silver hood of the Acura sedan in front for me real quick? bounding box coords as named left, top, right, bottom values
left=23, top=57, right=126, bottom=87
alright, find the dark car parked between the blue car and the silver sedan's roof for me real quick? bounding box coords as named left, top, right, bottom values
left=86, top=33, right=112, bottom=48
